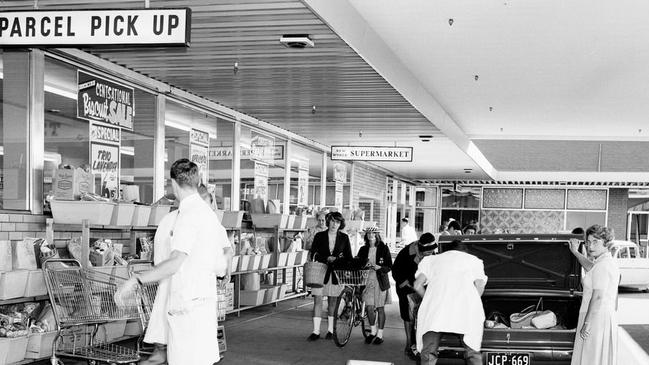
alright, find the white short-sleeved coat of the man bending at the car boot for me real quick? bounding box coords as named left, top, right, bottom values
left=415, top=250, right=487, bottom=351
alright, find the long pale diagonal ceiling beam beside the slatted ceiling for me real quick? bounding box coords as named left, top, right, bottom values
left=302, top=0, right=498, bottom=179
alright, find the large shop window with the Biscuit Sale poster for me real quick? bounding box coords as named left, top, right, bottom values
left=43, top=58, right=156, bottom=203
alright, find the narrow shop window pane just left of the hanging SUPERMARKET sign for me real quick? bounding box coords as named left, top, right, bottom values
left=290, top=144, right=322, bottom=215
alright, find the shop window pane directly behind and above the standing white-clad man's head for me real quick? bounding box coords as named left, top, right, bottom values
left=165, top=101, right=217, bottom=200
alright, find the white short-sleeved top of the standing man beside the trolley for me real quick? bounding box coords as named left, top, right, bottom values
left=169, top=194, right=230, bottom=310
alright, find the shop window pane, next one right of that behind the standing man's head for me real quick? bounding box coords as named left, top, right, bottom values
left=239, top=126, right=286, bottom=213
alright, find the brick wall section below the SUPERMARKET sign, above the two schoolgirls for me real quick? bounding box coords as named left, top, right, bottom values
left=351, top=163, right=386, bottom=229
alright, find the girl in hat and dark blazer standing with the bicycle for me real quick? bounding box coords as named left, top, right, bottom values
left=358, top=227, right=392, bottom=345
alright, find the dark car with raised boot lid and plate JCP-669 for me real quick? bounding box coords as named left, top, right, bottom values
left=439, top=234, right=583, bottom=365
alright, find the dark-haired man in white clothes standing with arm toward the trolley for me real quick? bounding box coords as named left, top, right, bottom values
left=116, top=159, right=229, bottom=365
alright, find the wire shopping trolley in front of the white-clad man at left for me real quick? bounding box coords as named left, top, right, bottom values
left=43, top=259, right=140, bottom=365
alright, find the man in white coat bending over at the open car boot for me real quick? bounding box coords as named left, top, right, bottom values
left=414, top=240, right=487, bottom=365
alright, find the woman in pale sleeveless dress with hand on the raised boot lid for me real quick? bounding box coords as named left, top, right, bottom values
left=570, top=224, right=620, bottom=365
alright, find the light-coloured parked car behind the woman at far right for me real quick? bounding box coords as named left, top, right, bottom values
left=610, top=241, right=649, bottom=290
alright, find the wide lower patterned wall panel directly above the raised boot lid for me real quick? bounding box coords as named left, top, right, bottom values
left=480, top=209, right=565, bottom=234
